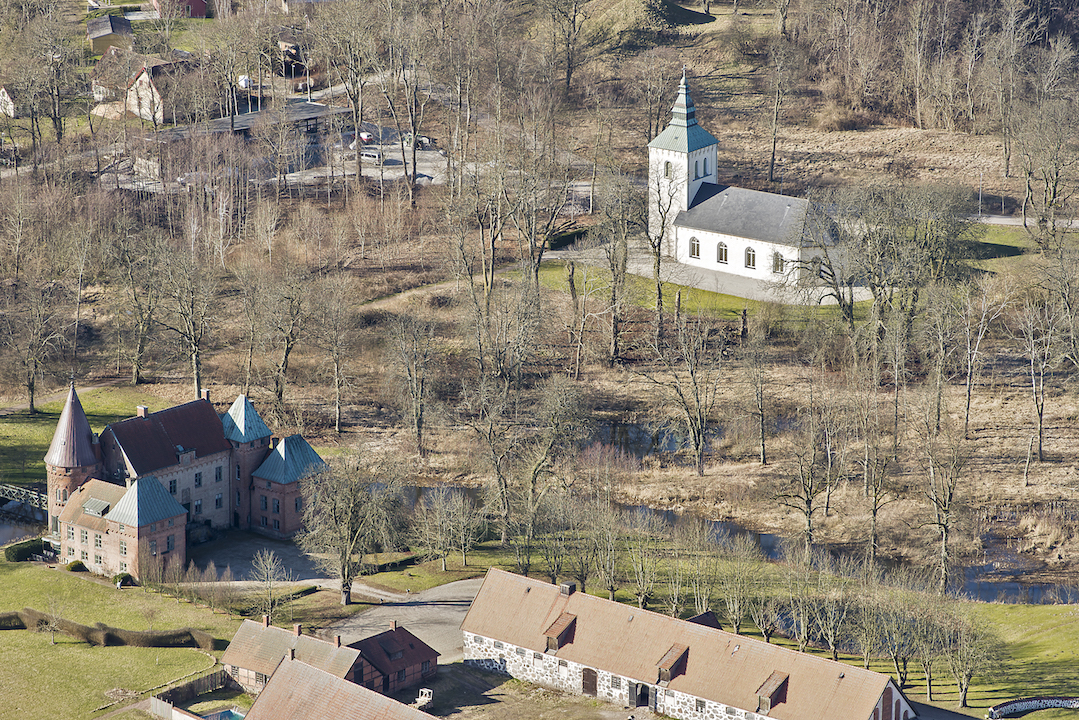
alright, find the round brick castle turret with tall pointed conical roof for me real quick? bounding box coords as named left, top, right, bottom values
left=45, top=382, right=101, bottom=534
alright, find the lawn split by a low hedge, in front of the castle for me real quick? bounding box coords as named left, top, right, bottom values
left=0, top=560, right=240, bottom=720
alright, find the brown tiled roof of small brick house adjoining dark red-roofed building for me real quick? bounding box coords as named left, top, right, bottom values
left=221, top=620, right=359, bottom=678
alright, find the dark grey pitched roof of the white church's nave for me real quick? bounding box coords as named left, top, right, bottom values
left=674, top=184, right=809, bottom=247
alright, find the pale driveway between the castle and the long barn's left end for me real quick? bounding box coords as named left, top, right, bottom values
left=323, top=578, right=483, bottom=665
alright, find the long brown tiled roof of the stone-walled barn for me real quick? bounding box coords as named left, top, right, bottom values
left=461, top=568, right=899, bottom=720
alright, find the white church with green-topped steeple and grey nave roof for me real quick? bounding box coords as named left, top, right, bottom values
left=648, top=70, right=827, bottom=302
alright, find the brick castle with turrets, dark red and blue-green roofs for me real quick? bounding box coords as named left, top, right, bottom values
left=45, top=383, right=325, bottom=576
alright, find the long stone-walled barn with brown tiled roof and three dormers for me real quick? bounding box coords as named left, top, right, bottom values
left=461, top=568, right=917, bottom=720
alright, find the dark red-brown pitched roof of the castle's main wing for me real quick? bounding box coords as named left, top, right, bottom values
left=106, top=399, right=232, bottom=477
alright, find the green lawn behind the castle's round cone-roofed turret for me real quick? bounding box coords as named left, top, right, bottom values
left=0, top=388, right=168, bottom=485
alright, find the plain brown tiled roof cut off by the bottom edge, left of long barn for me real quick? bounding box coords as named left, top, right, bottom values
left=245, top=658, right=433, bottom=720
